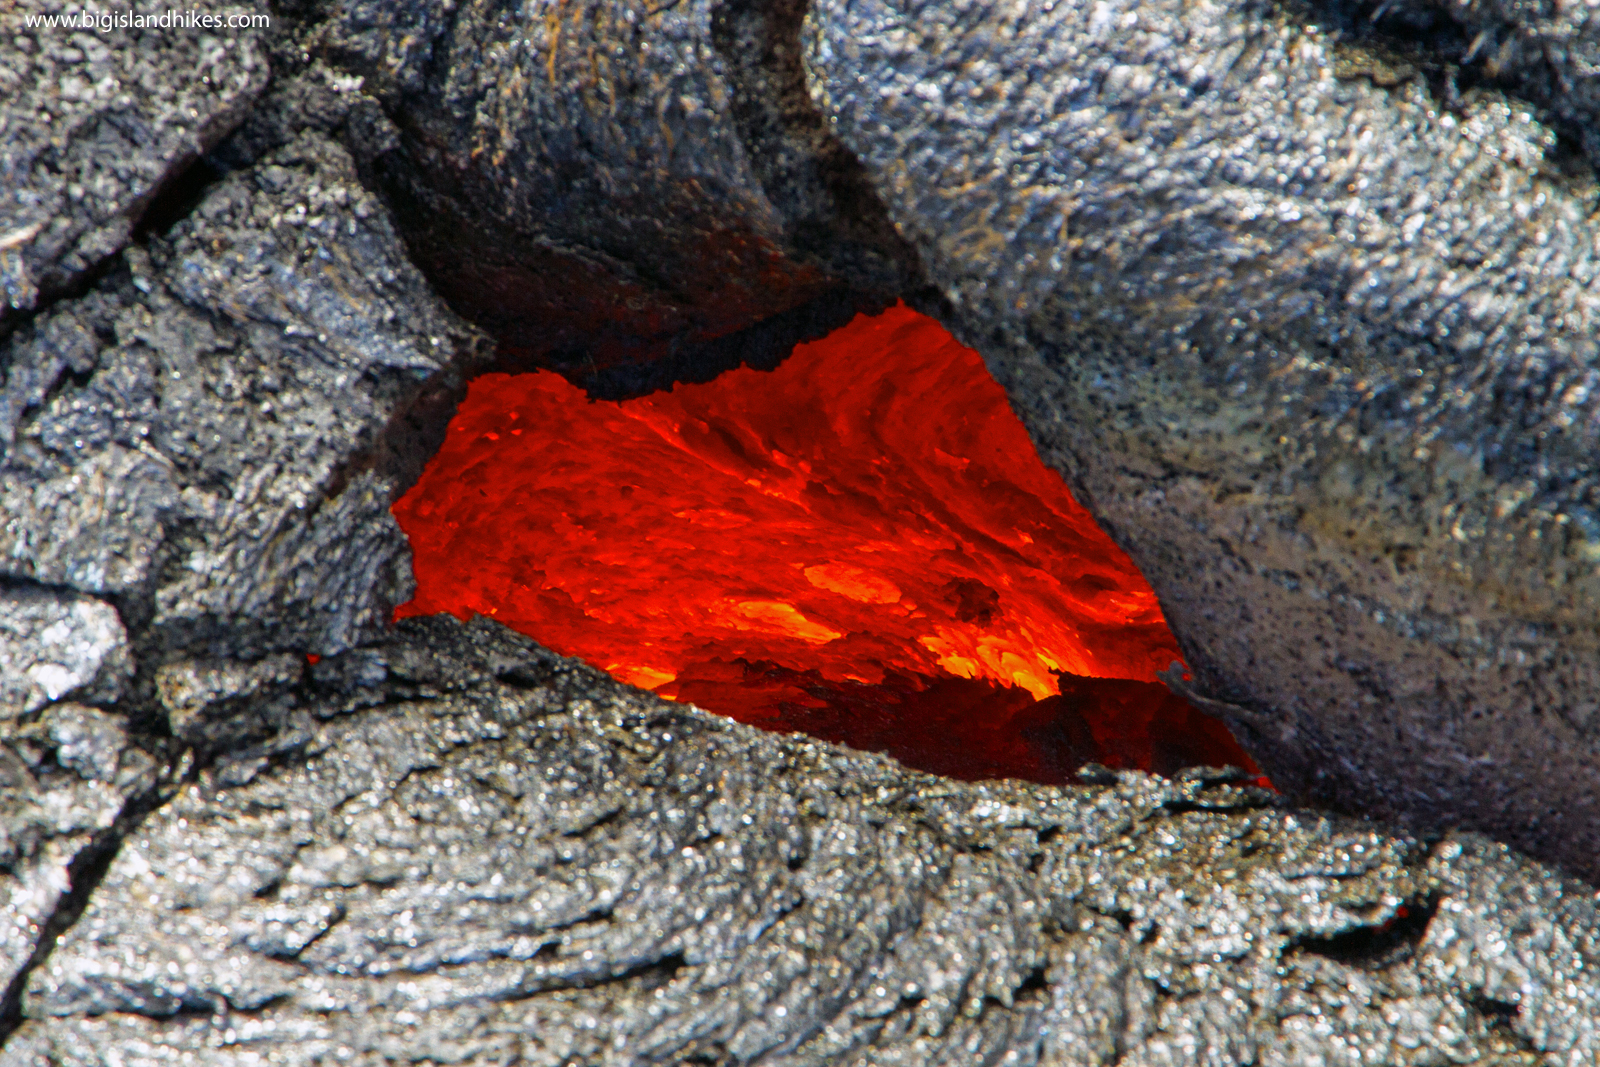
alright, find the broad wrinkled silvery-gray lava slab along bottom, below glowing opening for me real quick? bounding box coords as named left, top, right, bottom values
left=0, top=619, right=1600, bottom=1067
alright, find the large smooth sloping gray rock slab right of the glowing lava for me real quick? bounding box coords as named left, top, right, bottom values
left=806, top=0, right=1600, bottom=880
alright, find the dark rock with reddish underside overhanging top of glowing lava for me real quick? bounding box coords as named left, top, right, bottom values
left=315, top=0, right=915, bottom=392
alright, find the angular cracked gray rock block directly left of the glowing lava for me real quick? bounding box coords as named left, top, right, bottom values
left=0, top=133, right=480, bottom=659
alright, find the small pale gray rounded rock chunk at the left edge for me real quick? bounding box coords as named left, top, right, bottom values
left=0, top=587, right=133, bottom=723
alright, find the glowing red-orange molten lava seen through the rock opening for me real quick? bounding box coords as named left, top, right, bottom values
left=394, top=307, right=1254, bottom=782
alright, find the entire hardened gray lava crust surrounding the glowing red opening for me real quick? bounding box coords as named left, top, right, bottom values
left=0, top=0, right=1600, bottom=1067
